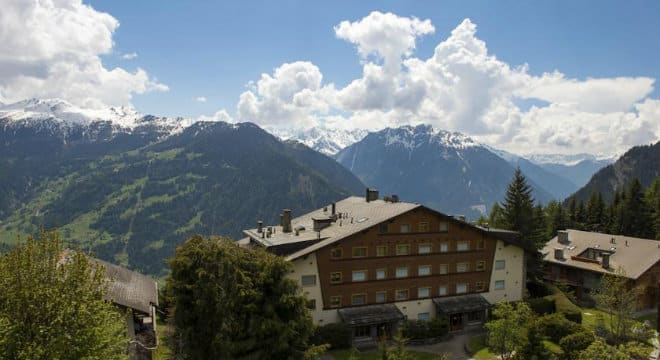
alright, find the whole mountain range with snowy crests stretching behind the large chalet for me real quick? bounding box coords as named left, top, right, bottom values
left=0, top=99, right=620, bottom=275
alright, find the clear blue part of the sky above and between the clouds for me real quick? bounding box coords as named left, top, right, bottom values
left=87, top=0, right=660, bottom=117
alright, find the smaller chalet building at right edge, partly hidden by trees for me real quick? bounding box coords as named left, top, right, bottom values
left=542, top=230, right=660, bottom=310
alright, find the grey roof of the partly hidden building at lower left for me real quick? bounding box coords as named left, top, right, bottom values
left=94, top=259, right=158, bottom=314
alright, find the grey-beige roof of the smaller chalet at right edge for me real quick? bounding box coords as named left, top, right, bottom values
left=541, top=230, right=660, bottom=279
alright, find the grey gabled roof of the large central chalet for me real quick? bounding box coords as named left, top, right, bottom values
left=240, top=196, right=520, bottom=260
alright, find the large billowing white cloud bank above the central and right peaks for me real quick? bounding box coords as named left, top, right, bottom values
left=217, top=12, right=660, bottom=155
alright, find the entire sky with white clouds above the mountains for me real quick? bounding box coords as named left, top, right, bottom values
left=0, top=0, right=660, bottom=155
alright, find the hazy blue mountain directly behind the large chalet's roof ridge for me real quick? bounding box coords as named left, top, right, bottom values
left=336, top=125, right=552, bottom=217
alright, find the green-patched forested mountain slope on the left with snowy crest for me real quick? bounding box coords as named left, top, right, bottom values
left=0, top=101, right=364, bottom=275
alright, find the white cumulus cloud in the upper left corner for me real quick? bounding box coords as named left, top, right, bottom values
left=0, top=0, right=168, bottom=107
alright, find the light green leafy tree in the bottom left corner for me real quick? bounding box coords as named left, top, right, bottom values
left=0, top=232, right=128, bottom=360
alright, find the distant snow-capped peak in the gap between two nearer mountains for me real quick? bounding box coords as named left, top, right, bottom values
left=267, top=127, right=369, bottom=155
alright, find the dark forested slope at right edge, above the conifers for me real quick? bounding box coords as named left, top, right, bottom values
left=574, top=142, right=660, bottom=201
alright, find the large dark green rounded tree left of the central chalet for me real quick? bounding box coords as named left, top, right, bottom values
left=167, top=235, right=313, bottom=359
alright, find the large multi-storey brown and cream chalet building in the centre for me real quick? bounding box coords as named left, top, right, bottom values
left=239, top=189, right=525, bottom=341
